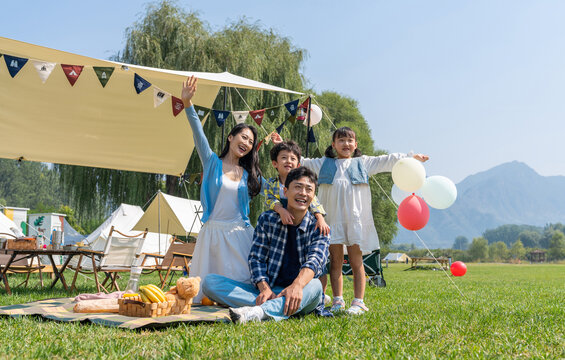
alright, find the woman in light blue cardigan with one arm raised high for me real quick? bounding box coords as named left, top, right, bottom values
left=181, top=76, right=261, bottom=303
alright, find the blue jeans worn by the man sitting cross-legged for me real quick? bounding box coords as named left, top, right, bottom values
left=202, top=274, right=323, bottom=321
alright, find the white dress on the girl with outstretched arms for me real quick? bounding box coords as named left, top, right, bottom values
left=300, top=154, right=406, bottom=254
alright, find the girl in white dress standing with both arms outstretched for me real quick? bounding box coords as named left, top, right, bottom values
left=302, top=127, right=429, bottom=315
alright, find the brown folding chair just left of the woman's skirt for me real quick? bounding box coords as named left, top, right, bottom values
left=141, top=242, right=196, bottom=288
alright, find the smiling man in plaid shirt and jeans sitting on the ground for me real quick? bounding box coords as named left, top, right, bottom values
left=202, top=167, right=329, bottom=323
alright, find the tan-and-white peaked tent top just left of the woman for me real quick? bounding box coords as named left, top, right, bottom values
left=133, top=191, right=202, bottom=236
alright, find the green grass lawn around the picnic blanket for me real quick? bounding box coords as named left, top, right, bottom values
left=0, top=264, right=565, bottom=359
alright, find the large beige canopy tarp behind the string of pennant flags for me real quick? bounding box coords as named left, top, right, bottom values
left=0, top=37, right=299, bottom=176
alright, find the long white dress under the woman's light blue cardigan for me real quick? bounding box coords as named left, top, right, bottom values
left=190, top=174, right=253, bottom=303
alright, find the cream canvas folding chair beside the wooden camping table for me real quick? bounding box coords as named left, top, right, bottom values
left=69, top=226, right=148, bottom=292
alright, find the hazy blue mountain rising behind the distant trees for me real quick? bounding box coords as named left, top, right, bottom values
left=394, top=161, right=565, bottom=248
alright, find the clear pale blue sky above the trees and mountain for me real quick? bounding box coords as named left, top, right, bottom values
left=0, top=0, right=565, bottom=182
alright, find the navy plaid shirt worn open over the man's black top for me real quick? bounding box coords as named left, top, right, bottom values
left=248, top=210, right=330, bottom=287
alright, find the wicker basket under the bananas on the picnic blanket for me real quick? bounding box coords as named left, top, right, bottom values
left=118, top=296, right=192, bottom=317
